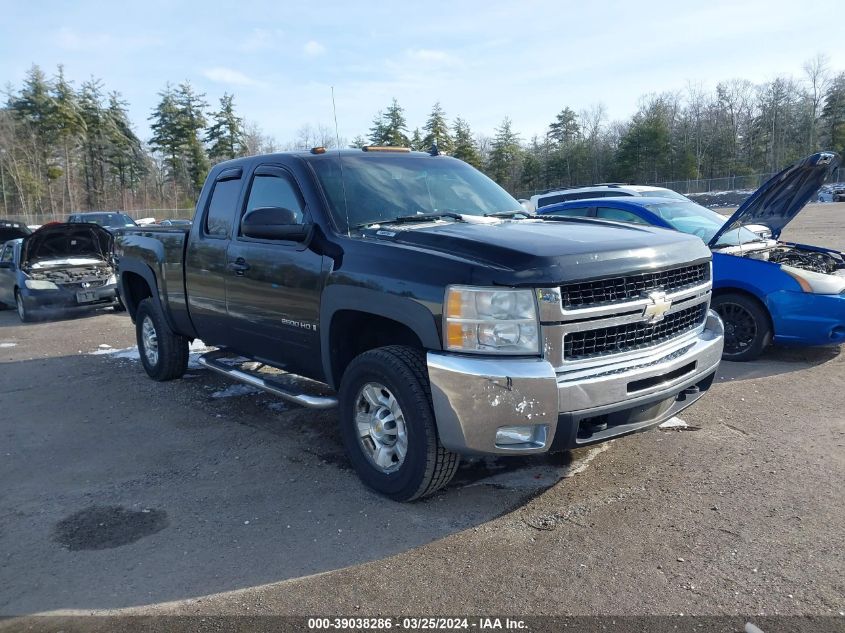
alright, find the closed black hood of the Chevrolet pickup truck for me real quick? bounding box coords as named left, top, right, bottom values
left=365, top=218, right=710, bottom=285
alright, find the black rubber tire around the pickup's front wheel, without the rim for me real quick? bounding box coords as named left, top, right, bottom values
left=338, top=345, right=460, bottom=501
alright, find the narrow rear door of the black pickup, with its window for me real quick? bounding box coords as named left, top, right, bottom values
left=185, top=167, right=243, bottom=345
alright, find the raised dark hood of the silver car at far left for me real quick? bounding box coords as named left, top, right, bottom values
left=21, top=223, right=114, bottom=268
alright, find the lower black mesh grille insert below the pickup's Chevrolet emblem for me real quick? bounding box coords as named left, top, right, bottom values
left=563, top=303, right=707, bottom=361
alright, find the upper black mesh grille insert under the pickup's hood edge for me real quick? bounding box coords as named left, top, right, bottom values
left=560, top=262, right=710, bottom=310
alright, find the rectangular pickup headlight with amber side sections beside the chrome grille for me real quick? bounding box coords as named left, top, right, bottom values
left=444, top=286, right=540, bottom=354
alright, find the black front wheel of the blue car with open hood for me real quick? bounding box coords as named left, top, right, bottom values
left=712, top=292, right=772, bottom=361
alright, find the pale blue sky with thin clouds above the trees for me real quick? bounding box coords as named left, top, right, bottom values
left=0, top=0, right=845, bottom=144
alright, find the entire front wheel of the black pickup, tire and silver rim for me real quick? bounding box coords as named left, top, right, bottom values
left=338, top=345, right=460, bottom=501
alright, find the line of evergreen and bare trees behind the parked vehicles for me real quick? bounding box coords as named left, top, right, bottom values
left=0, top=55, right=845, bottom=221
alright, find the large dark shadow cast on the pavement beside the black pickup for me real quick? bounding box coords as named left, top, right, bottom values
left=0, top=354, right=592, bottom=615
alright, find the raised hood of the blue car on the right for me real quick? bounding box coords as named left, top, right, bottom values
left=708, top=152, right=840, bottom=248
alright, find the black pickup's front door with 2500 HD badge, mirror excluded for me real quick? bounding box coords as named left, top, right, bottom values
left=226, top=163, right=323, bottom=376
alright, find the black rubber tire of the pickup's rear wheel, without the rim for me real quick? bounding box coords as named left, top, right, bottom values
left=135, top=297, right=188, bottom=381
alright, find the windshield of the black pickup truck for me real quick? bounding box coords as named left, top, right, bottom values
left=312, top=153, right=524, bottom=231
